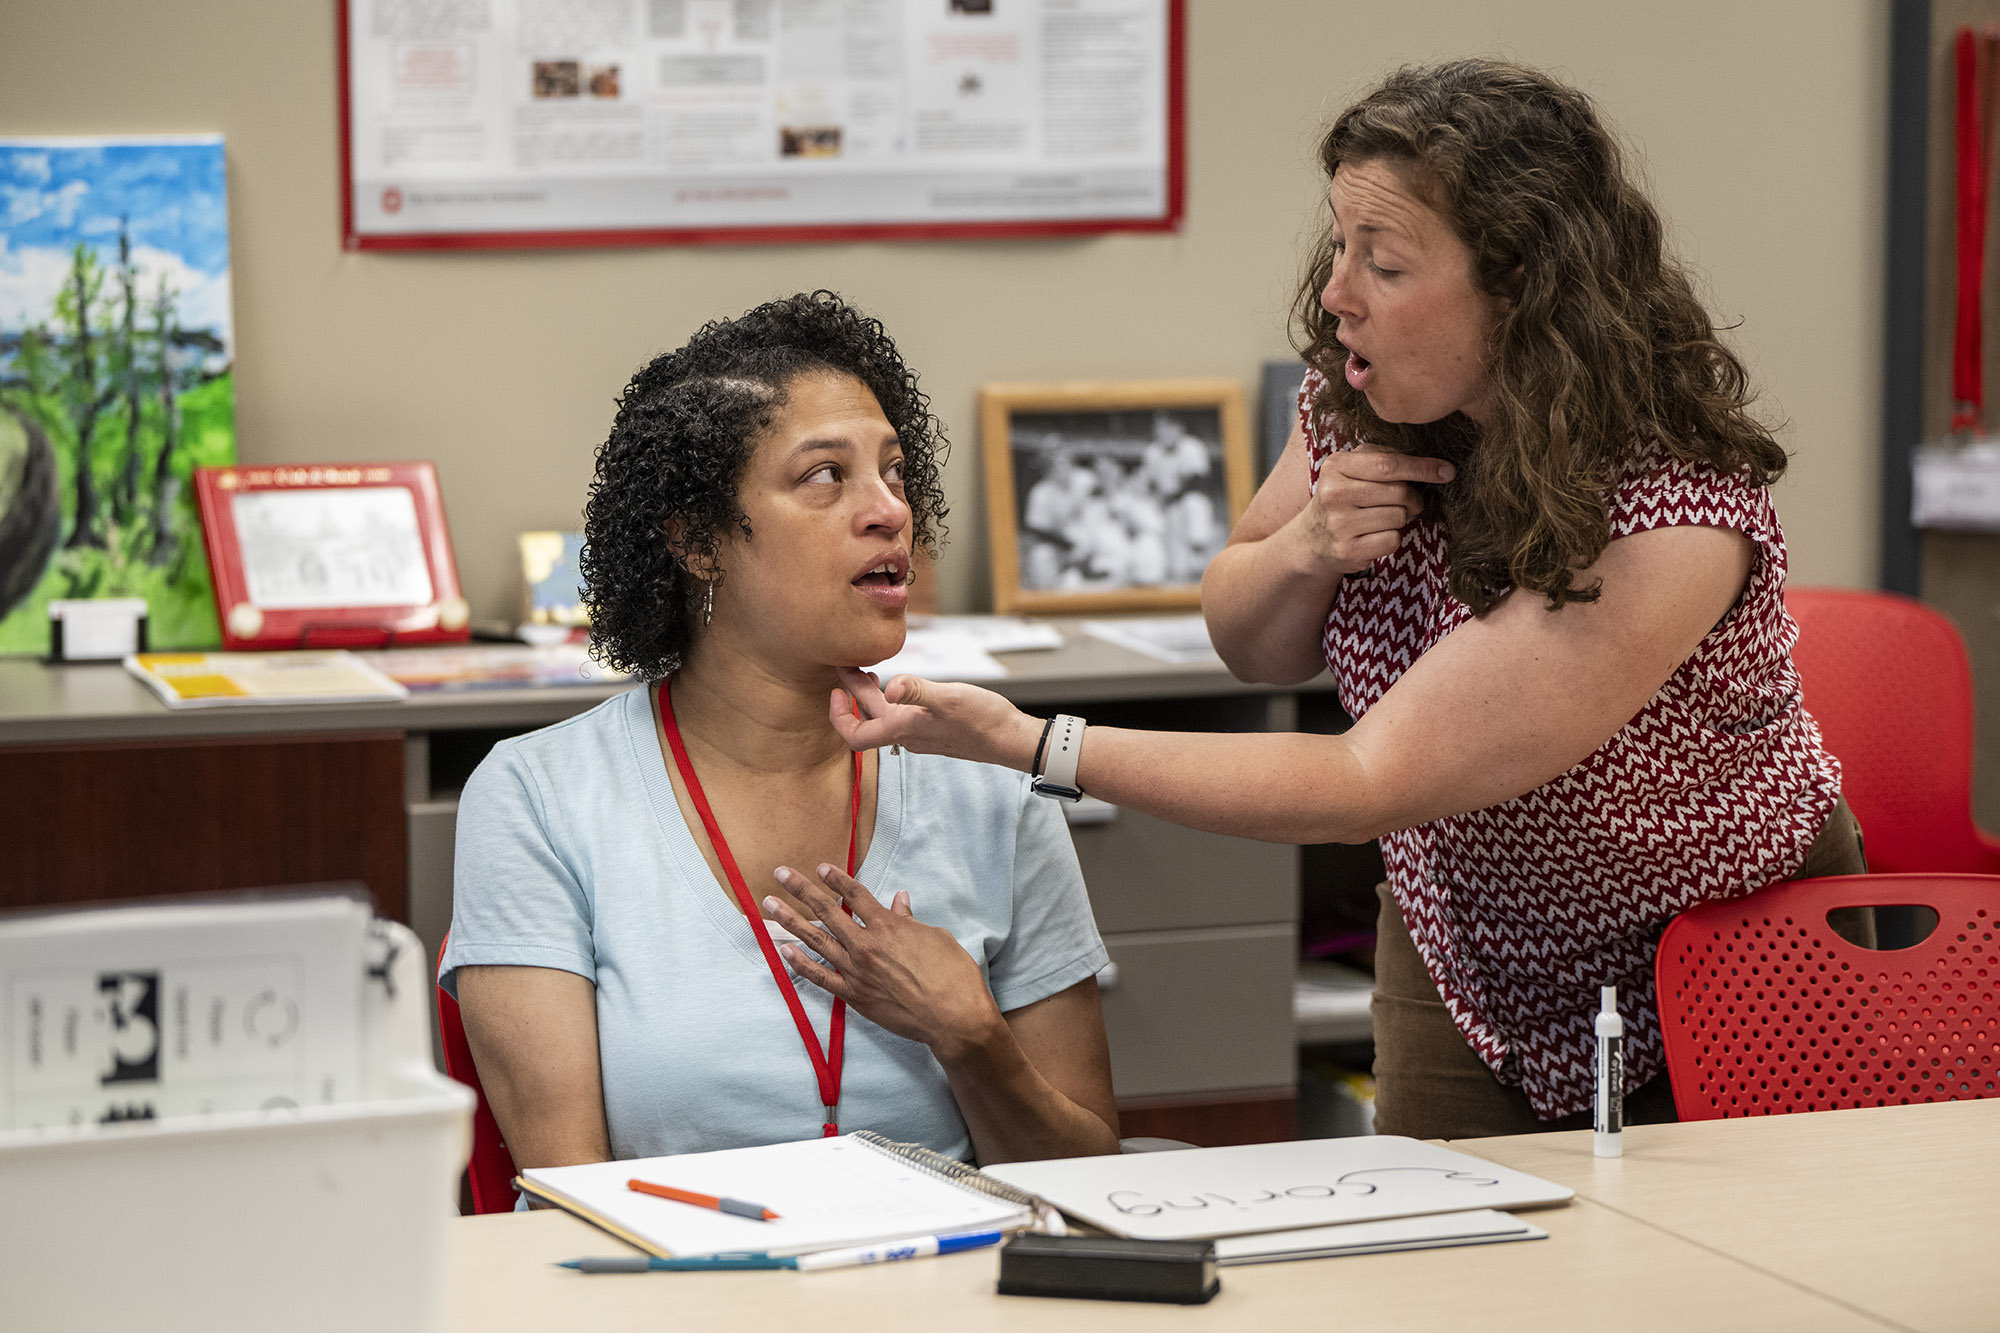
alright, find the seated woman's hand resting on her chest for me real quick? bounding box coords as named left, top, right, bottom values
left=764, top=865, right=1010, bottom=1065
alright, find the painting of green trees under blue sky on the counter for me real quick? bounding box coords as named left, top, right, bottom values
left=0, top=136, right=236, bottom=652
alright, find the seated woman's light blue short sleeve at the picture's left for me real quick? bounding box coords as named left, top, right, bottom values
left=438, top=743, right=596, bottom=997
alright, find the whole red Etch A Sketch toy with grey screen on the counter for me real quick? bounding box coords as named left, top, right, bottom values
left=194, top=462, right=472, bottom=650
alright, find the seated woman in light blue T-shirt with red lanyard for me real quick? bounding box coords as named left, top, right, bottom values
left=440, top=292, right=1118, bottom=1167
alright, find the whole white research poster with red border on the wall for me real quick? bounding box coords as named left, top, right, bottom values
left=340, top=0, right=1184, bottom=250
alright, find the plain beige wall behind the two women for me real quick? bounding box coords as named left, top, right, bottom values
left=0, top=0, right=1888, bottom=616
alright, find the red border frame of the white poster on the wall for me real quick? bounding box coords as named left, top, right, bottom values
left=334, top=0, right=1188, bottom=250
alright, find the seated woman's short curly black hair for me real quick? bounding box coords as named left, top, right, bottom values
left=582, top=290, right=950, bottom=681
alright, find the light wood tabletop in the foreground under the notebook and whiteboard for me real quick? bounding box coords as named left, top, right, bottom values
left=446, top=1101, right=2000, bottom=1333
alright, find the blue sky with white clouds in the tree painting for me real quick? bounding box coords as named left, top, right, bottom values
left=0, top=136, right=232, bottom=344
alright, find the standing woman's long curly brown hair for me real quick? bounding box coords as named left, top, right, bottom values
left=1294, top=60, right=1786, bottom=612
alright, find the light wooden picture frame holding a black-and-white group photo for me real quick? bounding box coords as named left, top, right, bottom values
left=980, top=380, right=1254, bottom=614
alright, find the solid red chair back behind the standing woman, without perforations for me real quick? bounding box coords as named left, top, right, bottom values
left=1784, top=588, right=2000, bottom=875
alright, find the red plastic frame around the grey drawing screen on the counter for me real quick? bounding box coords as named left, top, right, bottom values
left=194, top=462, right=470, bottom=652
